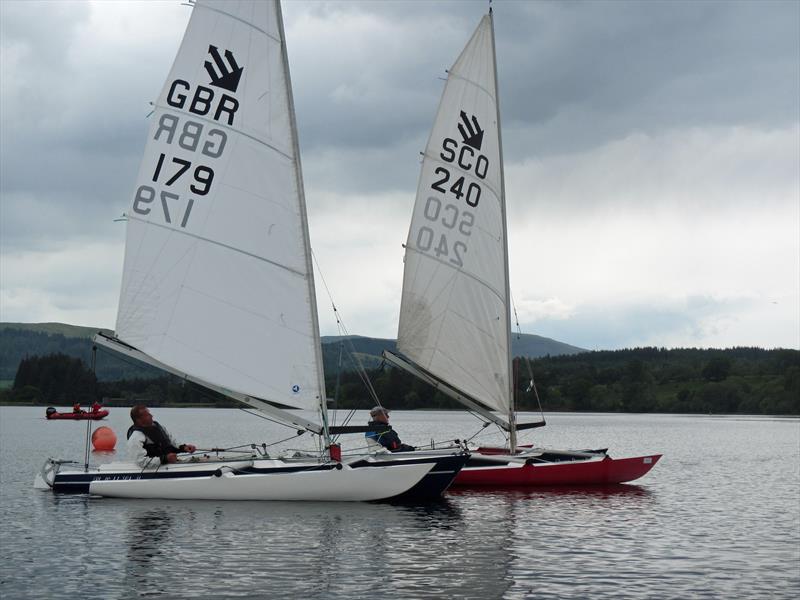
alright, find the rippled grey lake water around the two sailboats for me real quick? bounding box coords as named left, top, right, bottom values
left=0, top=407, right=800, bottom=599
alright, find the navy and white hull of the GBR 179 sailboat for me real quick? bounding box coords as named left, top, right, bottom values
left=39, top=453, right=468, bottom=502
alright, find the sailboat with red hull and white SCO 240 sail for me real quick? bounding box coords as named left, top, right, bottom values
left=384, top=9, right=660, bottom=485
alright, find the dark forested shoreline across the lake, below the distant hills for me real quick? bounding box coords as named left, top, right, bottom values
left=0, top=348, right=800, bottom=415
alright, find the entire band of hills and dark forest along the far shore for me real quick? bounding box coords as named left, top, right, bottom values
left=0, top=323, right=800, bottom=414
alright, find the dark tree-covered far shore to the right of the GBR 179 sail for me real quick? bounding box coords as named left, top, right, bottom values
left=328, top=348, right=800, bottom=415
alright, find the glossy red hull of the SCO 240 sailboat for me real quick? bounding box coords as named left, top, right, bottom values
left=453, top=454, right=661, bottom=487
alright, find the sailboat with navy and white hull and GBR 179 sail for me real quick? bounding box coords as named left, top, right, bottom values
left=41, top=0, right=467, bottom=500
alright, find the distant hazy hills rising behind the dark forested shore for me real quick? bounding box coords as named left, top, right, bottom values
left=0, top=323, right=586, bottom=381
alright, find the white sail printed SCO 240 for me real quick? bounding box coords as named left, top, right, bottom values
left=397, top=14, right=513, bottom=419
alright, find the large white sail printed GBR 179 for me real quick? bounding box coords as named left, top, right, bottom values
left=116, top=0, right=324, bottom=409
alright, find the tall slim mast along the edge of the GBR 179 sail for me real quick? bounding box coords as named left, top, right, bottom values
left=276, top=0, right=331, bottom=446
